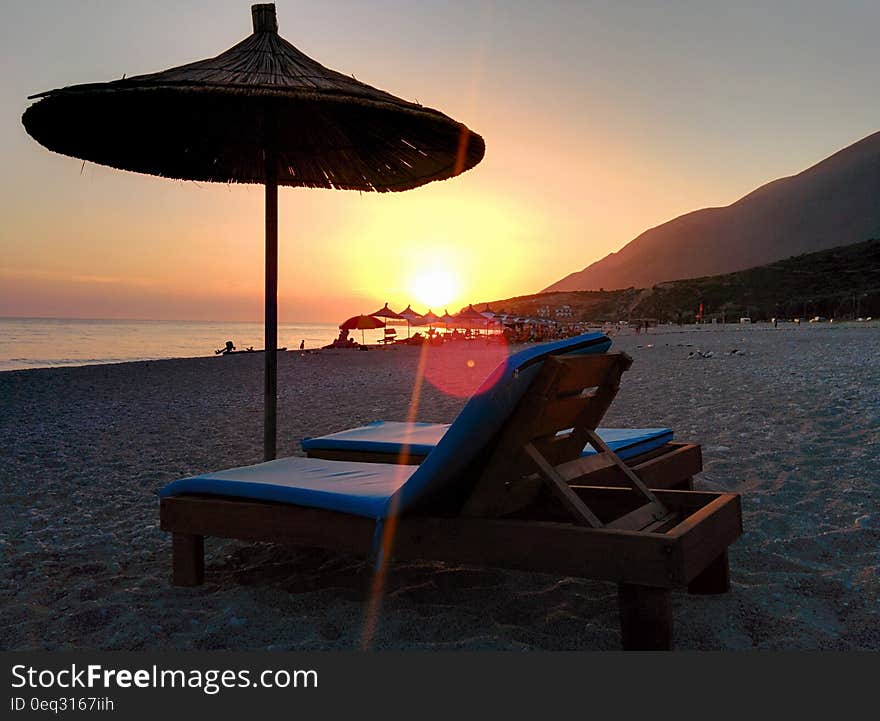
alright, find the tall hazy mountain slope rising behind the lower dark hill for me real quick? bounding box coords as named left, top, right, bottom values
left=544, top=132, right=880, bottom=292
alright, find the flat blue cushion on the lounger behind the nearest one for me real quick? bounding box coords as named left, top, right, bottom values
left=302, top=421, right=673, bottom=458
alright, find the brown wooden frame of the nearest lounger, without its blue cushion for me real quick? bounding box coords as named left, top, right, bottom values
left=161, top=353, right=742, bottom=650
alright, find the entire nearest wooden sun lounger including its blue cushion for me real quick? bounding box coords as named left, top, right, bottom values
left=160, top=334, right=742, bottom=649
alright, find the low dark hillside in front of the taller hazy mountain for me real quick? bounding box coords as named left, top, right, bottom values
left=490, top=239, right=880, bottom=323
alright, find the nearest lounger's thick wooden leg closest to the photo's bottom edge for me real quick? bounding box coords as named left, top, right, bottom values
left=617, top=583, right=672, bottom=651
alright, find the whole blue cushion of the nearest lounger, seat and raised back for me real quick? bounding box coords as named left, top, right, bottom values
left=159, top=333, right=611, bottom=519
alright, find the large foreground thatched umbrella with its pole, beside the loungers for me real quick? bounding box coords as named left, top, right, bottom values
left=22, top=4, right=485, bottom=459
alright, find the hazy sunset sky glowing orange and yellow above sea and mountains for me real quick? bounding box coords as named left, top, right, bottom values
left=0, top=0, right=880, bottom=321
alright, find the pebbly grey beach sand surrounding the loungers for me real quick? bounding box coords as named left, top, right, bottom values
left=0, top=325, right=880, bottom=650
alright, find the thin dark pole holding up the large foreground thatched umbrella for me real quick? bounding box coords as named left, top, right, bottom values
left=263, top=167, right=278, bottom=461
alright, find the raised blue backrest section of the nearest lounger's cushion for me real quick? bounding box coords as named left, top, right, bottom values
left=389, top=333, right=611, bottom=513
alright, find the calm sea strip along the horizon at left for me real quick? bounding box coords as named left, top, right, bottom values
left=0, top=318, right=348, bottom=371
